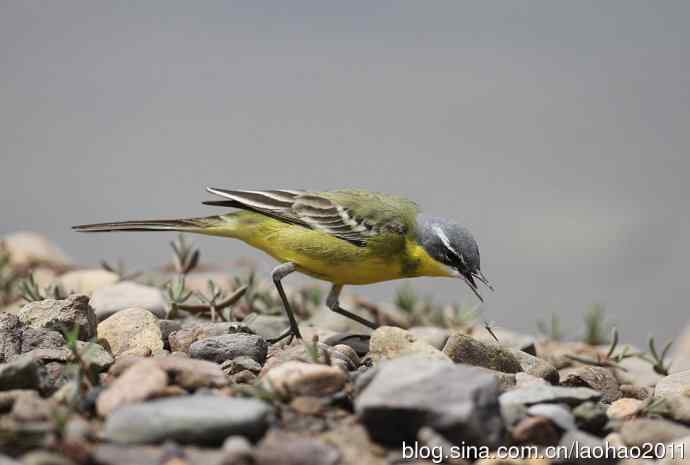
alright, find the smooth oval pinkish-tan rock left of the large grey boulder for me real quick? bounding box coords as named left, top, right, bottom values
left=262, top=361, right=347, bottom=397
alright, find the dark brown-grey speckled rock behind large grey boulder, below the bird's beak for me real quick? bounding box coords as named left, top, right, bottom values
left=443, top=333, right=522, bottom=373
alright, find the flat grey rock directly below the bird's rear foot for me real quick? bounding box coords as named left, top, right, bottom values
left=189, top=333, right=268, bottom=364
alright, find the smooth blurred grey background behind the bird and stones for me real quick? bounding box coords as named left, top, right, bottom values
left=0, top=0, right=690, bottom=341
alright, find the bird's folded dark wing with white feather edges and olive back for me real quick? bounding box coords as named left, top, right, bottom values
left=204, top=188, right=417, bottom=246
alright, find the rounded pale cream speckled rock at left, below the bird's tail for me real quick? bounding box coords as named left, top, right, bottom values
left=98, top=308, right=163, bottom=357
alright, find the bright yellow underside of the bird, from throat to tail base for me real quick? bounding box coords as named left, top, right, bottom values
left=207, top=212, right=452, bottom=285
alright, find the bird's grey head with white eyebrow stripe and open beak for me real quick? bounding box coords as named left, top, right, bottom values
left=417, top=216, right=493, bottom=301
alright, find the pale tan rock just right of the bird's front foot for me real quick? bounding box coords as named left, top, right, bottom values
left=369, top=326, right=451, bottom=363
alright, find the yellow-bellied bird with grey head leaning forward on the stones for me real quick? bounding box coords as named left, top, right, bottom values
left=72, top=187, right=494, bottom=343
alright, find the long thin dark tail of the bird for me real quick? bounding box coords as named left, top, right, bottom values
left=72, top=214, right=235, bottom=236
